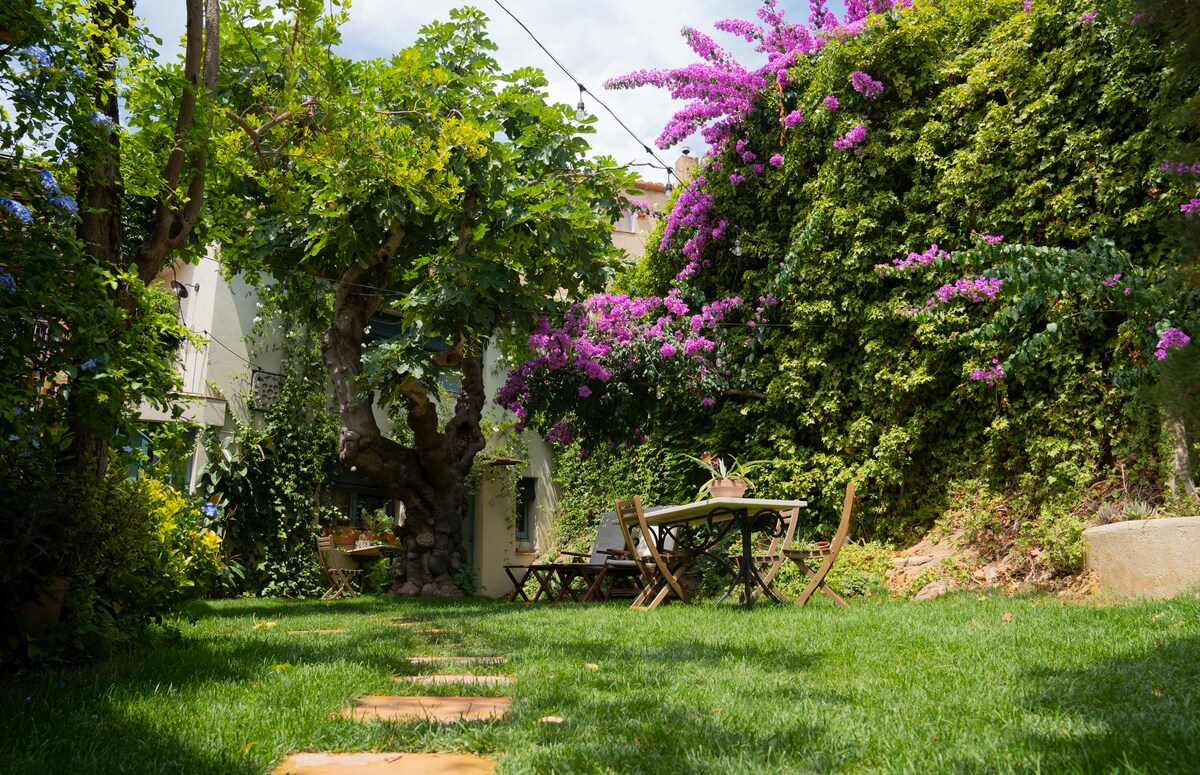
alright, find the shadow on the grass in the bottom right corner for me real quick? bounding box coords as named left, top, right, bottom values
left=1003, top=632, right=1200, bottom=773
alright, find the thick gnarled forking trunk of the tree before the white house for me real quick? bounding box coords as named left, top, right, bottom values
left=320, top=230, right=485, bottom=596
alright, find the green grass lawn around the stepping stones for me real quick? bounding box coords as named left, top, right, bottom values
left=0, top=594, right=1200, bottom=774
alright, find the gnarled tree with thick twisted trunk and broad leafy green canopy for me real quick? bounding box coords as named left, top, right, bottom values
left=212, top=1, right=629, bottom=594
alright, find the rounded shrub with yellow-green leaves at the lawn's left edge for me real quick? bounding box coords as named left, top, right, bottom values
left=0, top=453, right=222, bottom=663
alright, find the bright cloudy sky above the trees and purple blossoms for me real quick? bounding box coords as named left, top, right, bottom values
left=137, top=0, right=842, bottom=184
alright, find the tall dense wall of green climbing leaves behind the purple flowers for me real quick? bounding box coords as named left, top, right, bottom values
left=604, top=0, right=1195, bottom=569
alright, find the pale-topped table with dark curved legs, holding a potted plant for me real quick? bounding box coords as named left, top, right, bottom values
left=626, top=498, right=809, bottom=608
